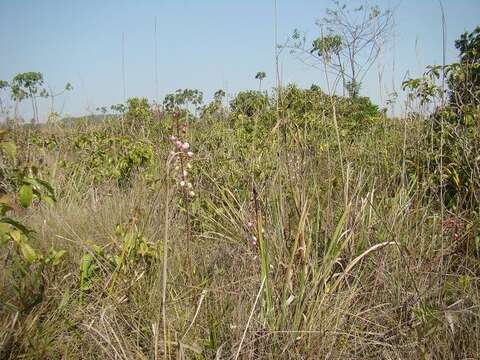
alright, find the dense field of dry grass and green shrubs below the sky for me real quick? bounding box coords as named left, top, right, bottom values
left=0, top=18, right=480, bottom=359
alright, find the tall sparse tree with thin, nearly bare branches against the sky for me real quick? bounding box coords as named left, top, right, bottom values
left=285, top=1, right=393, bottom=98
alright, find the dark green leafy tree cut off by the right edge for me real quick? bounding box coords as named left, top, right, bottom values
left=403, top=28, right=480, bottom=209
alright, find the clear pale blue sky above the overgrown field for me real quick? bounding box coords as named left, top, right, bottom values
left=0, top=0, right=480, bottom=117
